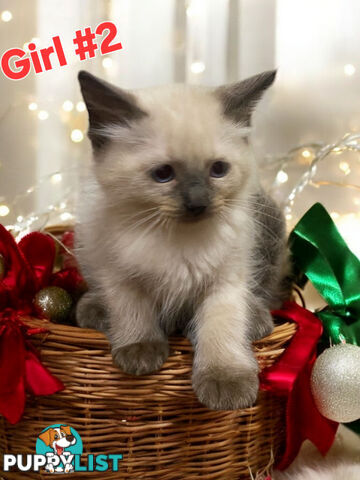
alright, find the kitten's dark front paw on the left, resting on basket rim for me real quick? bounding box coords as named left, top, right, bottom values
left=112, top=341, right=169, bottom=375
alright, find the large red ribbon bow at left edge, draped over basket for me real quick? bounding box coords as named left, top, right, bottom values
left=0, top=225, right=82, bottom=423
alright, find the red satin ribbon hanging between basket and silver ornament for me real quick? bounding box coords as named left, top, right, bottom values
left=260, top=302, right=338, bottom=470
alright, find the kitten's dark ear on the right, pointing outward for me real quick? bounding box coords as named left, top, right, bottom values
left=216, top=70, right=276, bottom=126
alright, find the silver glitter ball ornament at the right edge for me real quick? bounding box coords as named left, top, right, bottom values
left=311, top=343, right=360, bottom=423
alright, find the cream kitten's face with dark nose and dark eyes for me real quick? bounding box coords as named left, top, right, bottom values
left=79, top=70, right=276, bottom=227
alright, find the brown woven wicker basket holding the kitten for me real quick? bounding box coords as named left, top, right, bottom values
left=0, top=319, right=296, bottom=480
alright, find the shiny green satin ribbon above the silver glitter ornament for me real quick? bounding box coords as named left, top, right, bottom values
left=289, top=203, right=360, bottom=345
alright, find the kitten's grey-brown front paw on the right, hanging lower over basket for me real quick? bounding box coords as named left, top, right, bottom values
left=192, top=368, right=259, bottom=410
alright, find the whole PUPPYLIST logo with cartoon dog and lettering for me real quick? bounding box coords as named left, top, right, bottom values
left=3, top=423, right=122, bottom=474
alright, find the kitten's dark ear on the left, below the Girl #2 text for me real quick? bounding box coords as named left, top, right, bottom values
left=78, top=70, right=146, bottom=149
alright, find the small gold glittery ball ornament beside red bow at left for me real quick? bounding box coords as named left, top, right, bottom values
left=34, top=287, right=73, bottom=323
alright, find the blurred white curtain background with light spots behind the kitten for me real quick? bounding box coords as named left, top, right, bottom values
left=0, top=0, right=360, bottom=253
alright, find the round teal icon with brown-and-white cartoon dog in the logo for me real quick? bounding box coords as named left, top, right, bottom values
left=36, top=424, right=82, bottom=473
